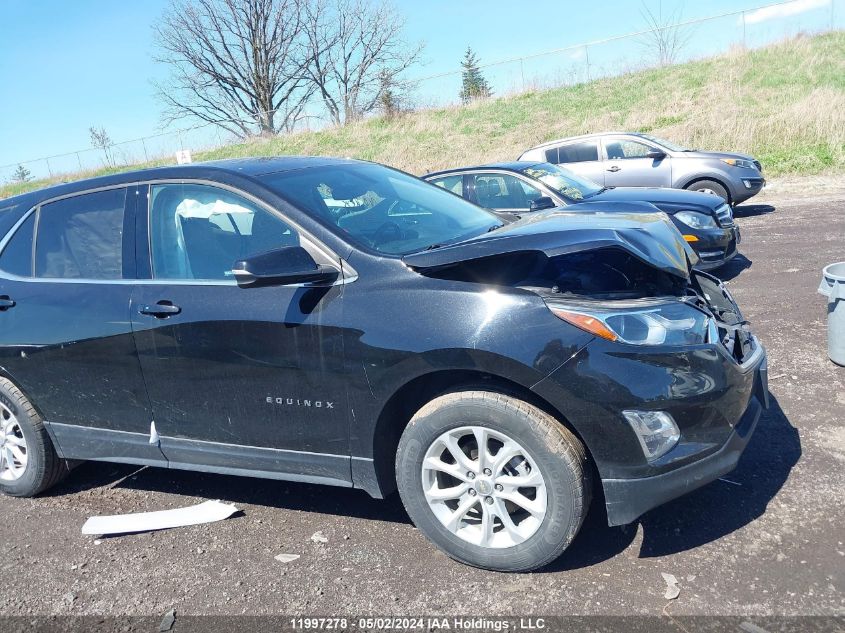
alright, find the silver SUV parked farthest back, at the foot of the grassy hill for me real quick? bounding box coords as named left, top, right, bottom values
left=519, top=132, right=766, bottom=205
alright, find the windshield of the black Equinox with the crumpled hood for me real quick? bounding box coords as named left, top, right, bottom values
left=260, top=163, right=502, bottom=255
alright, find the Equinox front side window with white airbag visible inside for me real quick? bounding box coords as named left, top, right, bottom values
left=150, top=184, right=299, bottom=280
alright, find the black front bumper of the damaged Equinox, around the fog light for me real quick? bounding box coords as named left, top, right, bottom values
left=535, top=330, right=768, bottom=526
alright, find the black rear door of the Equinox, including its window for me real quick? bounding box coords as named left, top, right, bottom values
left=0, top=186, right=163, bottom=463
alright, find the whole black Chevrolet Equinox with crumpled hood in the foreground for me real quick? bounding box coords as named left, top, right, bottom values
left=0, top=158, right=768, bottom=570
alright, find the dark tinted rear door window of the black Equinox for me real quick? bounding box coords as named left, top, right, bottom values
left=35, top=189, right=126, bottom=279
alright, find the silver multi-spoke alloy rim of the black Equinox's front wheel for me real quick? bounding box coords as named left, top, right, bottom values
left=422, top=426, right=548, bottom=548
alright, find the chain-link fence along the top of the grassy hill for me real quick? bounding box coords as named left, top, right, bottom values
left=0, top=0, right=845, bottom=184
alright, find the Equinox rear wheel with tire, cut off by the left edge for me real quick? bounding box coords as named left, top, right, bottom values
left=0, top=378, right=68, bottom=497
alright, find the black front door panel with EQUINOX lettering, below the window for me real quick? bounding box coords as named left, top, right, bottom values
left=132, top=284, right=348, bottom=455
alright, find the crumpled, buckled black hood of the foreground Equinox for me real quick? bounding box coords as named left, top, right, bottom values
left=403, top=209, right=698, bottom=279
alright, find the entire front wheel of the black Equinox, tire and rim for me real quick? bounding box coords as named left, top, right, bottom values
left=396, top=391, right=591, bottom=571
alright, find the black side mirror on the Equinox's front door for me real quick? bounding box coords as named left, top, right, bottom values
left=232, top=246, right=339, bottom=288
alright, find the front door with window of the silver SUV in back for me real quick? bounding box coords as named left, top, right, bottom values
left=604, top=137, right=672, bottom=187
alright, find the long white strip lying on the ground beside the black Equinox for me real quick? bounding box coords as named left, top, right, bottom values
left=82, top=501, right=238, bottom=534
